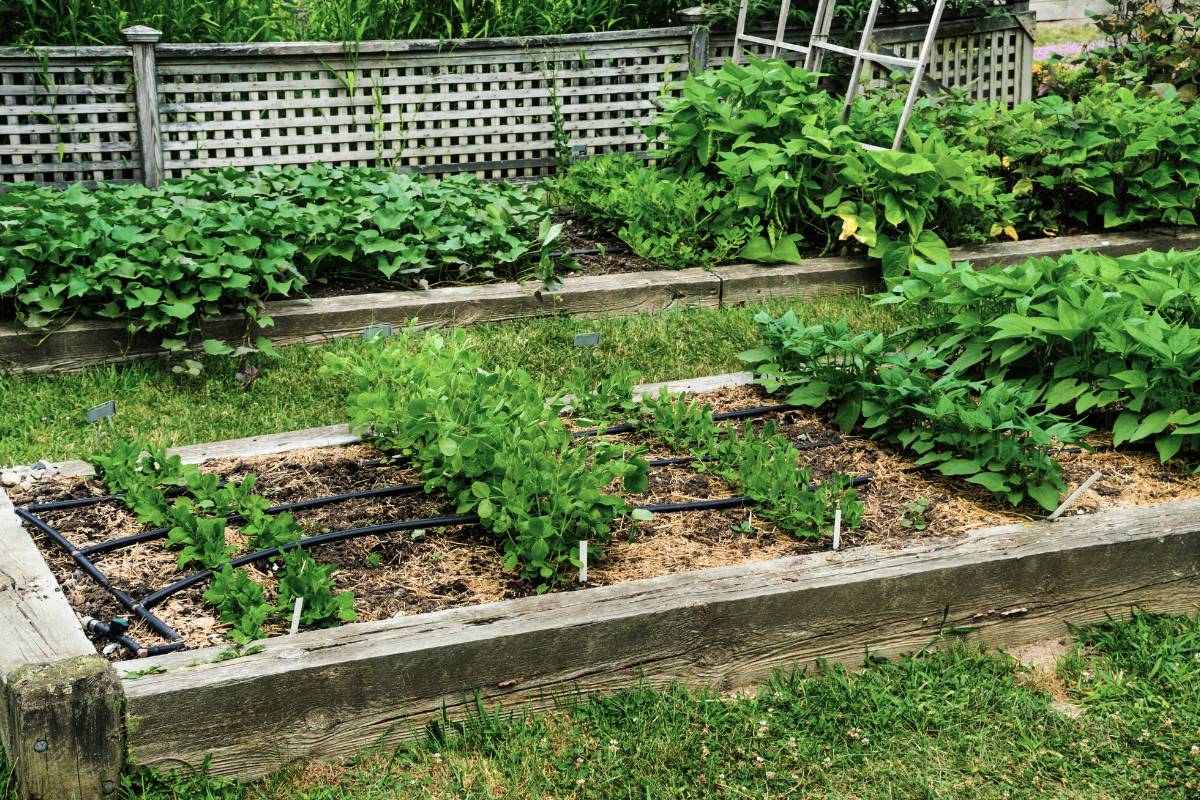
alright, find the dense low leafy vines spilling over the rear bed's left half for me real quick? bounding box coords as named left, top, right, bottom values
left=0, top=164, right=560, bottom=354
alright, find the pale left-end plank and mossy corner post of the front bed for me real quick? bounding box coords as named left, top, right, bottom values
left=0, top=489, right=125, bottom=800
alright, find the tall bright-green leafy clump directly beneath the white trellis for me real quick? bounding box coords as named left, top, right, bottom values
left=564, top=58, right=1010, bottom=273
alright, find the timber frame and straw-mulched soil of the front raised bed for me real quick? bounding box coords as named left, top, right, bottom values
left=0, top=381, right=1200, bottom=796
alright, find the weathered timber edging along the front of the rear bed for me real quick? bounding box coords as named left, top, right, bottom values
left=0, top=229, right=1200, bottom=372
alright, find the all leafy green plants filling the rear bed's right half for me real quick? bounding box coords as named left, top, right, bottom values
left=559, top=58, right=1200, bottom=276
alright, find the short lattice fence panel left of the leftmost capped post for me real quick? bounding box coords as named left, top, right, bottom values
left=0, top=47, right=142, bottom=184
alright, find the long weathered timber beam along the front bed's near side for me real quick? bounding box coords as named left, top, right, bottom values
left=125, top=500, right=1200, bottom=777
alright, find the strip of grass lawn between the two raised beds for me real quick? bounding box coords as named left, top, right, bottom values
left=0, top=295, right=898, bottom=465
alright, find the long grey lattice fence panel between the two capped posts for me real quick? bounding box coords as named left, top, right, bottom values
left=158, top=35, right=688, bottom=178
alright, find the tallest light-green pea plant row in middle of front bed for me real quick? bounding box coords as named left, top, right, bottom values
left=326, top=331, right=648, bottom=591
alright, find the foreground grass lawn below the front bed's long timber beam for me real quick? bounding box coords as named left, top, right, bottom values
left=0, top=614, right=1200, bottom=800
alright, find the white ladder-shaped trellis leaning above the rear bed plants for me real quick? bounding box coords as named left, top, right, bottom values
left=733, top=0, right=946, bottom=150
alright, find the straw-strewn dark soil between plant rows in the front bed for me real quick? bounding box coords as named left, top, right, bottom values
left=13, top=386, right=1200, bottom=662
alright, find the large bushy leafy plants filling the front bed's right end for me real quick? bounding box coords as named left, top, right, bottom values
left=742, top=252, right=1200, bottom=509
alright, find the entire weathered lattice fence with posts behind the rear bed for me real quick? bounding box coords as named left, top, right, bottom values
left=0, top=14, right=1032, bottom=185
